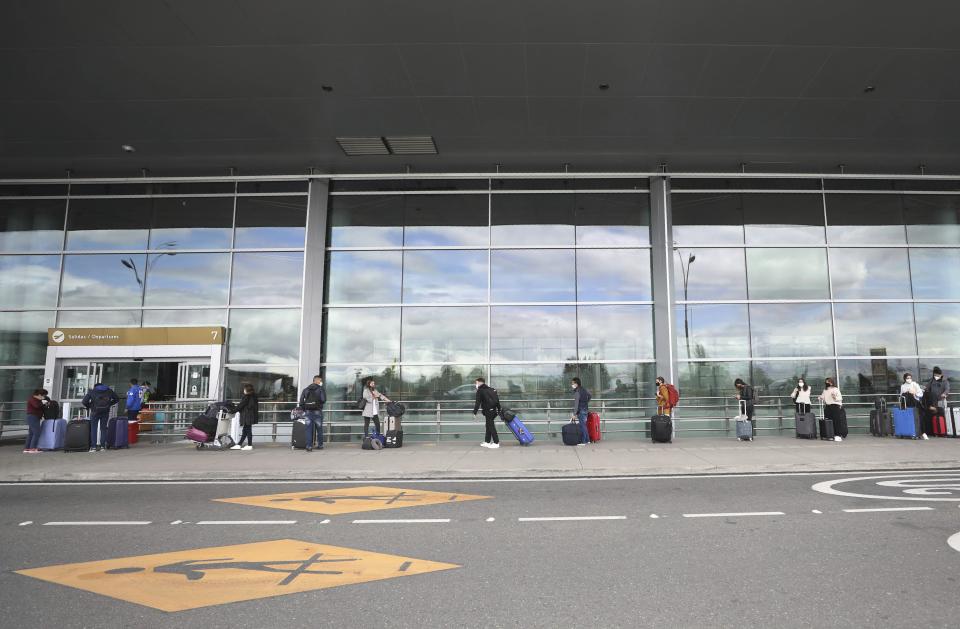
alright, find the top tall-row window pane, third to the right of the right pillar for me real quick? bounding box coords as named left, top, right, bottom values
left=827, top=194, right=906, bottom=245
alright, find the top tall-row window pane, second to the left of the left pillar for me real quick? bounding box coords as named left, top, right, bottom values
left=150, top=197, right=233, bottom=249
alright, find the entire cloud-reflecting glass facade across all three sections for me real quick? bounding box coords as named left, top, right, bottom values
left=0, top=178, right=960, bottom=422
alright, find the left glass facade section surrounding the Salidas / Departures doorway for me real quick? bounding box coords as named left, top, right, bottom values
left=0, top=181, right=307, bottom=403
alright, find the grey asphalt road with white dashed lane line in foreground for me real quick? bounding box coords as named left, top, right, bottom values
left=0, top=471, right=960, bottom=629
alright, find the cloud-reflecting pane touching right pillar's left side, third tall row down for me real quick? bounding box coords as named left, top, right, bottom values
left=577, top=306, right=653, bottom=360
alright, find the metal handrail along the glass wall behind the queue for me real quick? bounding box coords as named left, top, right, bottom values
left=0, top=394, right=960, bottom=442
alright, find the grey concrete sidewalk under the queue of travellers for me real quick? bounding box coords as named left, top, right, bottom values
left=0, top=435, right=960, bottom=482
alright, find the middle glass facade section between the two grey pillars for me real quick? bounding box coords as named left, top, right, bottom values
left=323, top=188, right=655, bottom=400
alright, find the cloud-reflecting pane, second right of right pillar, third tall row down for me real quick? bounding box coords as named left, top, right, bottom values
left=750, top=304, right=833, bottom=358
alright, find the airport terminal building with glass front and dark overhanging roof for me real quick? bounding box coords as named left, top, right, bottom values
left=0, top=0, right=960, bottom=424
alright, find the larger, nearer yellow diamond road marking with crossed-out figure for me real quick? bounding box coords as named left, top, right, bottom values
left=17, top=539, right=460, bottom=612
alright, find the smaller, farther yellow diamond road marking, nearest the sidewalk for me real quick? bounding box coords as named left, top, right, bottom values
left=216, top=486, right=490, bottom=515
